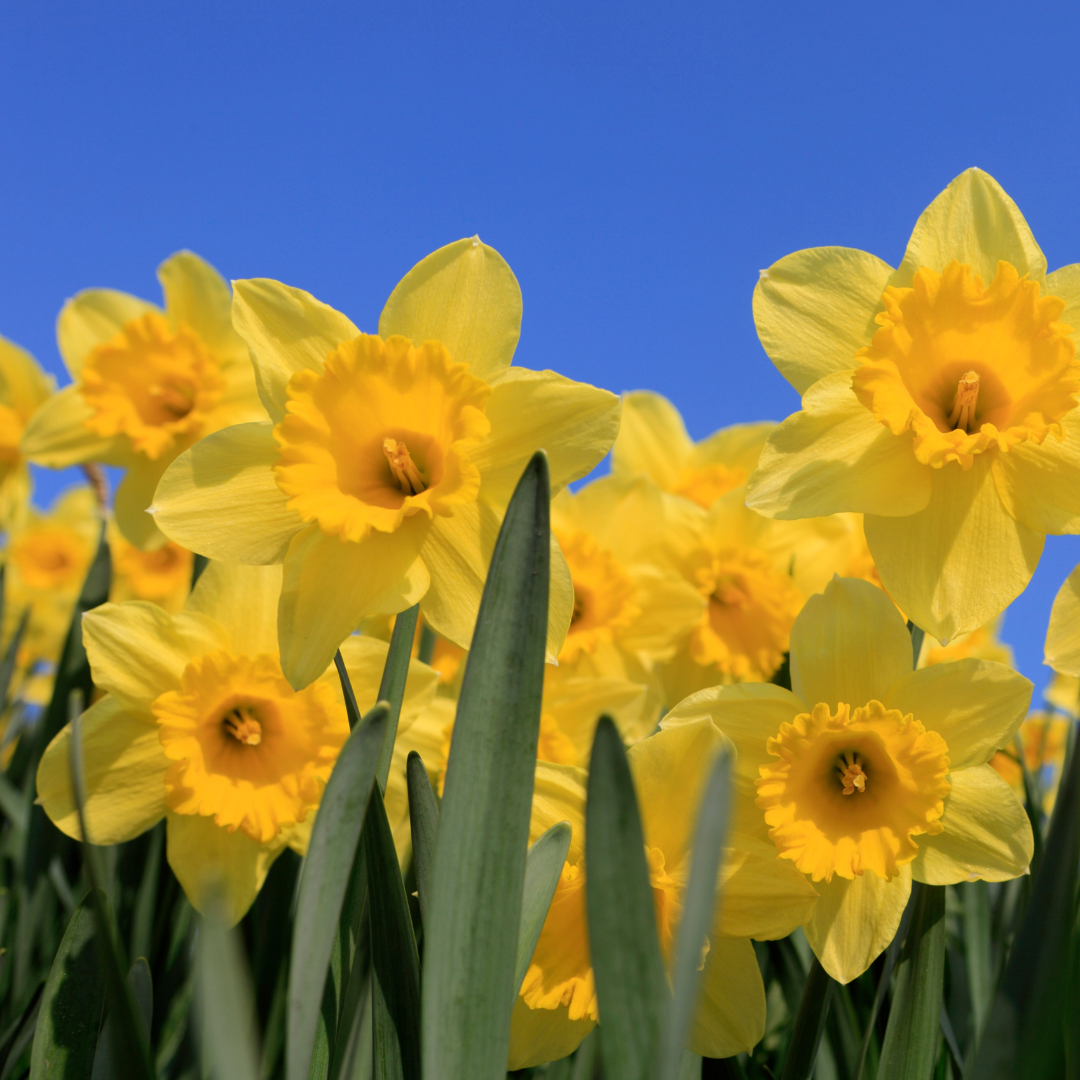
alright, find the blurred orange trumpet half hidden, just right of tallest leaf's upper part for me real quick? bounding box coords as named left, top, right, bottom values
left=555, top=529, right=642, bottom=663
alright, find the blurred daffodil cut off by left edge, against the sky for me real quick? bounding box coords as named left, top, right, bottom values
left=0, top=337, right=53, bottom=529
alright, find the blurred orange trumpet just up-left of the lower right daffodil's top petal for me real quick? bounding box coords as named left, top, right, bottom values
left=690, top=548, right=802, bottom=680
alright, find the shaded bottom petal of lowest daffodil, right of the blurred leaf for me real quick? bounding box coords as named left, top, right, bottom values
left=687, top=937, right=765, bottom=1057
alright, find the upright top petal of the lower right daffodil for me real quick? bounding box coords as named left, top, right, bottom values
left=792, top=578, right=912, bottom=708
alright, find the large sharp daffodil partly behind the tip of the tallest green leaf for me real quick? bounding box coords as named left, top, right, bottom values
left=153, top=238, right=619, bottom=687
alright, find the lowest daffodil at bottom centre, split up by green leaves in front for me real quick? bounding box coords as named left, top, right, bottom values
left=509, top=719, right=816, bottom=1069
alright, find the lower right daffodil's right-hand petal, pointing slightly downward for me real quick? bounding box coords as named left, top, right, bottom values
left=912, top=765, right=1035, bottom=885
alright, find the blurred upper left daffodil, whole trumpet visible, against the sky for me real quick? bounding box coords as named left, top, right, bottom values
left=22, top=252, right=262, bottom=548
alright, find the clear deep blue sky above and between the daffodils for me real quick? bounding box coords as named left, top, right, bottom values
left=0, top=0, right=1080, bottom=683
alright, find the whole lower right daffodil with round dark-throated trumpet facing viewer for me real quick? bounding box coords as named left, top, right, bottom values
left=661, top=578, right=1032, bottom=983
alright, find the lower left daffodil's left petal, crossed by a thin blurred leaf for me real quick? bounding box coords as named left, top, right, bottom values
left=37, top=697, right=168, bottom=843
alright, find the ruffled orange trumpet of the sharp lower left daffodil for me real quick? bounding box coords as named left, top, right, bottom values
left=151, top=650, right=349, bottom=843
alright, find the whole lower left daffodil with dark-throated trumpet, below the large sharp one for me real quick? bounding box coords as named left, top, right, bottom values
left=38, top=563, right=437, bottom=922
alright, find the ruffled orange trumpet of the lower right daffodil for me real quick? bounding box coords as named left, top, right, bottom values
left=756, top=701, right=949, bottom=881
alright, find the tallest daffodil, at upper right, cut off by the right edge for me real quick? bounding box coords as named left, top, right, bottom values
left=747, top=168, right=1080, bottom=642
